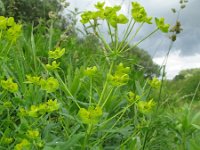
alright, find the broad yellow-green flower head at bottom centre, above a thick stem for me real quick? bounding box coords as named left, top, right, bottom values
left=78, top=106, right=103, bottom=124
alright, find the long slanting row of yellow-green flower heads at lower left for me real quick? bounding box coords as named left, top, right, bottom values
left=19, top=99, right=60, bottom=118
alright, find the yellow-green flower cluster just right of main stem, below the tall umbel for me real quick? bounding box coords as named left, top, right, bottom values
left=108, top=63, right=130, bottom=86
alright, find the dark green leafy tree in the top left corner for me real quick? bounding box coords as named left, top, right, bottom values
left=0, top=0, right=68, bottom=26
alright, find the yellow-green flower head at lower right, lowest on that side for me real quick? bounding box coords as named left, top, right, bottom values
left=137, top=99, right=155, bottom=114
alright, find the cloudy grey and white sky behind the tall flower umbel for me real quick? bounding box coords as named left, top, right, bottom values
left=68, top=0, right=200, bottom=79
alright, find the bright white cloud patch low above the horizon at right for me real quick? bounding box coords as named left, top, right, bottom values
left=153, top=50, right=200, bottom=79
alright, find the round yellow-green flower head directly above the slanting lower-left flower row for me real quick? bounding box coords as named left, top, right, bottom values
left=40, top=77, right=59, bottom=93
